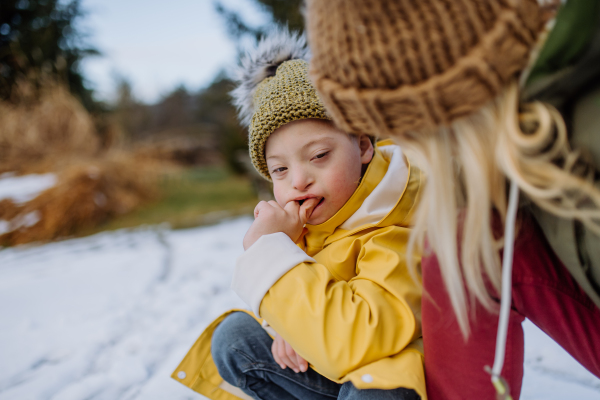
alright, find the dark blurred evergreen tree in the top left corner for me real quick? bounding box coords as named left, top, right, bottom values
left=0, top=0, right=98, bottom=110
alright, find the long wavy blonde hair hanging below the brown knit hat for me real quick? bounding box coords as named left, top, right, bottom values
left=398, top=82, right=600, bottom=337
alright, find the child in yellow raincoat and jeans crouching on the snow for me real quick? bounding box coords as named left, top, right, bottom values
left=173, top=32, right=426, bottom=400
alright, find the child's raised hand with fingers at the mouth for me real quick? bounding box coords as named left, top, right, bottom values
left=244, top=198, right=320, bottom=250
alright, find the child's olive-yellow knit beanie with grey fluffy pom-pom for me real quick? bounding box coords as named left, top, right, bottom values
left=231, top=28, right=331, bottom=181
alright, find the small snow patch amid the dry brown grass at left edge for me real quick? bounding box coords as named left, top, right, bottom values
left=0, top=172, right=57, bottom=204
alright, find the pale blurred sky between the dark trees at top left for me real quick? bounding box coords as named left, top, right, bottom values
left=80, top=0, right=267, bottom=103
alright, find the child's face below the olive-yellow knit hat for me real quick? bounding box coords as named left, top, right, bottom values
left=265, top=119, right=373, bottom=225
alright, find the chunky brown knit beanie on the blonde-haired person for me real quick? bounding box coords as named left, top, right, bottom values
left=306, top=0, right=542, bottom=136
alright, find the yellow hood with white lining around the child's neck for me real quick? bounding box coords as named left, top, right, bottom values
left=304, top=140, right=421, bottom=254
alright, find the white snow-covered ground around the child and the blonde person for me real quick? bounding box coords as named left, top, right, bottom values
left=0, top=218, right=600, bottom=400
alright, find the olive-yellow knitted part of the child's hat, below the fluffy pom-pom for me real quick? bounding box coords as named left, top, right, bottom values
left=249, top=60, right=331, bottom=181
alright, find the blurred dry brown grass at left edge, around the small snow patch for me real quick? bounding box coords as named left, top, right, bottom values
left=0, top=84, right=164, bottom=246
